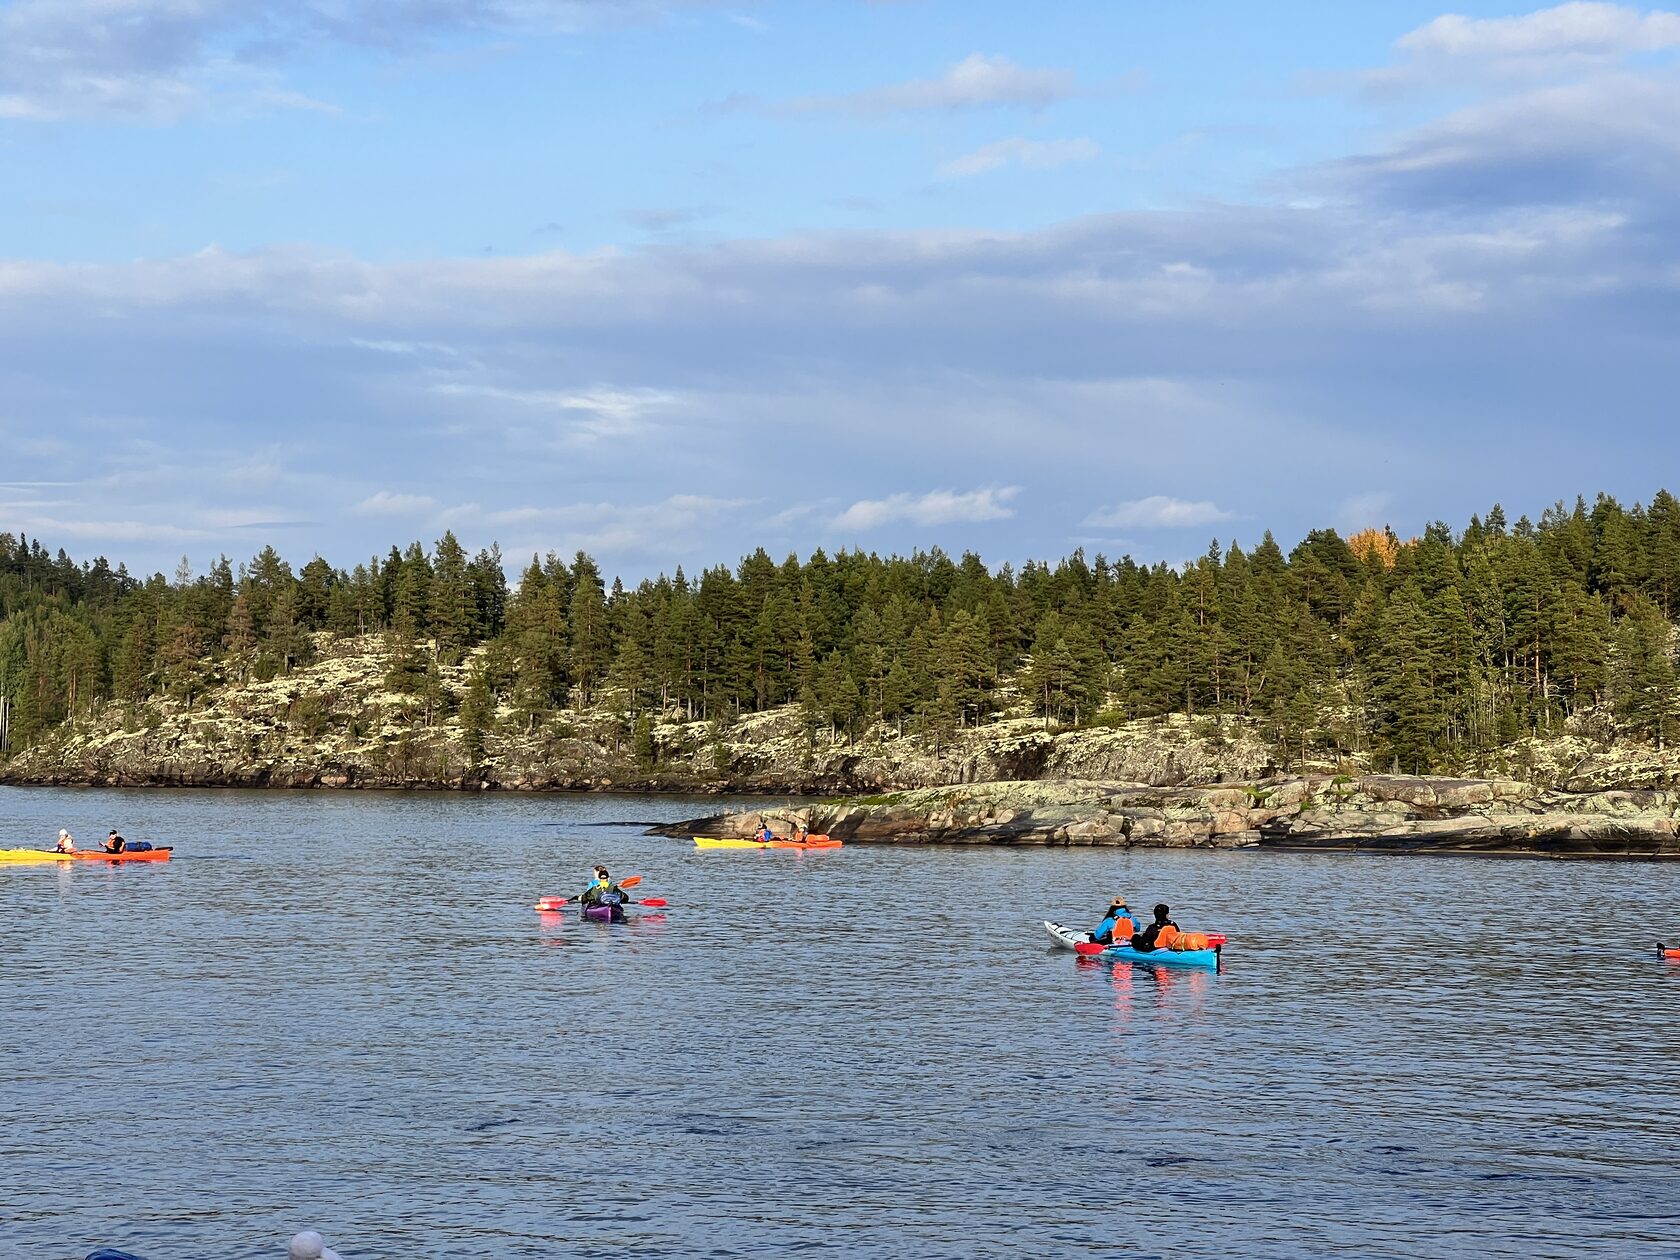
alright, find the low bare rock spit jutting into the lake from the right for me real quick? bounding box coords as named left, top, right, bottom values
left=655, top=774, right=1680, bottom=860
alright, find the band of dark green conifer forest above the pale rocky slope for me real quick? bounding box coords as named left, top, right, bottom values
left=0, top=491, right=1680, bottom=773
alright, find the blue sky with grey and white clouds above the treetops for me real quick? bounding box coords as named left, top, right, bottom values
left=0, top=0, right=1680, bottom=576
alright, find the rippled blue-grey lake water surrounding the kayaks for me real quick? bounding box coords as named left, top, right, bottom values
left=0, top=788, right=1680, bottom=1260
